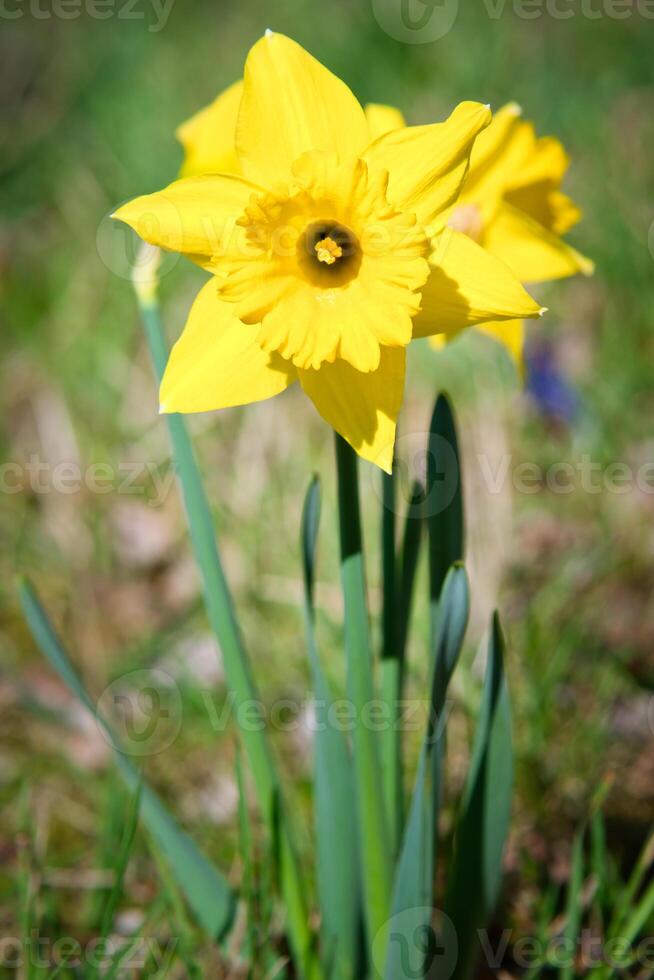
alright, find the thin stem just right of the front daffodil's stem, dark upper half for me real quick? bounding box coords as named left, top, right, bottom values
left=380, top=473, right=402, bottom=855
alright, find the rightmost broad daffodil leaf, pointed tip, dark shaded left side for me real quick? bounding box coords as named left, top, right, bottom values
left=445, top=613, right=513, bottom=978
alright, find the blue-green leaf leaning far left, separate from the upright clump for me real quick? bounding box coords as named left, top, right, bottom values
left=19, top=580, right=235, bottom=938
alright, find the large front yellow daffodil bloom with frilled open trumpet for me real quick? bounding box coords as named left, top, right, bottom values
left=115, top=32, right=542, bottom=471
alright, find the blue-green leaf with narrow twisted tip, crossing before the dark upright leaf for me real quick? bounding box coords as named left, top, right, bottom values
left=384, top=565, right=470, bottom=980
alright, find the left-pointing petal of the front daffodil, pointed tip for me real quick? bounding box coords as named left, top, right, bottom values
left=112, top=174, right=261, bottom=257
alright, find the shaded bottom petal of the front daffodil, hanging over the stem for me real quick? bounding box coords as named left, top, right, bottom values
left=298, top=347, right=406, bottom=473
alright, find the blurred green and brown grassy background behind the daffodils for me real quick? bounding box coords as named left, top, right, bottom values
left=0, top=0, right=654, bottom=976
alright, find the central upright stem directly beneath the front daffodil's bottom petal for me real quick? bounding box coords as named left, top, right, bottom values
left=336, top=435, right=393, bottom=964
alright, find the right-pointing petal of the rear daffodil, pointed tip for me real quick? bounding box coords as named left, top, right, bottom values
left=482, top=204, right=594, bottom=282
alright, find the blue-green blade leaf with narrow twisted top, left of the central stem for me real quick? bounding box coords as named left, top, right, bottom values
left=301, top=477, right=364, bottom=980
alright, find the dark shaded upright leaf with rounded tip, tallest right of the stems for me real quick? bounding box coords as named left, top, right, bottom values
left=426, top=395, right=464, bottom=605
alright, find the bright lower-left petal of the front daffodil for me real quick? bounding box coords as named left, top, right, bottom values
left=160, top=279, right=297, bottom=412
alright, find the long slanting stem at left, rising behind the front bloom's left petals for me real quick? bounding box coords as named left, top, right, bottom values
left=137, top=289, right=318, bottom=978
